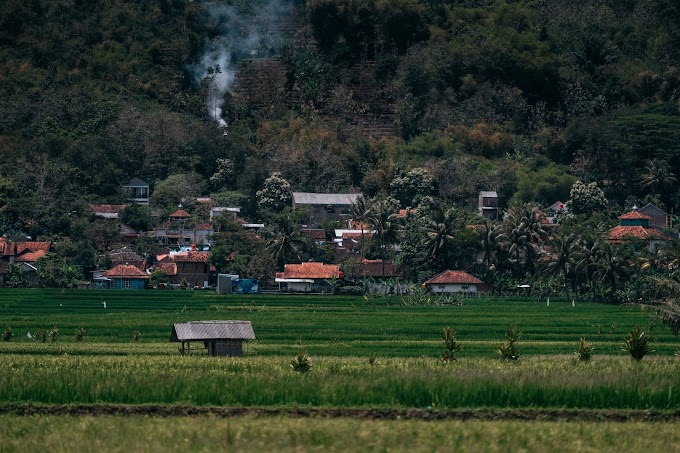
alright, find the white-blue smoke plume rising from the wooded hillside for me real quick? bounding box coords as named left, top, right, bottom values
left=187, top=0, right=292, bottom=127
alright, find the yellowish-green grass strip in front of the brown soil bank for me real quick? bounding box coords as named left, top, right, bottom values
left=0, top=415, right=680, bottom=452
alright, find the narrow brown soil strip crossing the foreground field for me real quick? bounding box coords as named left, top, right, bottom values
left=0, top=404, right=680, bottom=422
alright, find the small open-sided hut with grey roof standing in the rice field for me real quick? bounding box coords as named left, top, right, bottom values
left=170, top=321, right=255, bottom=357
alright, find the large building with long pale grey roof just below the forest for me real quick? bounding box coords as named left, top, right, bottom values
left=293, top=192, right=361, bottom=227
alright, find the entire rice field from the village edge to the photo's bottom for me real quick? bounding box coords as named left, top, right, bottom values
left=0, top=289, right=680, bottom=451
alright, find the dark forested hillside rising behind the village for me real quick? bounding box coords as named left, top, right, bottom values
left=0, top=0, right=680, bottom=237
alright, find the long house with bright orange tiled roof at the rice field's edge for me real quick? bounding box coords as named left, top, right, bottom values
left=275, top=262, right=342, bottom=293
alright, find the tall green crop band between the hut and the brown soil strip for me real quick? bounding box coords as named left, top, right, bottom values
left=0, top=354, right=680, bottom=410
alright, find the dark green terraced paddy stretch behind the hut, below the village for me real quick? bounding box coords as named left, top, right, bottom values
left=0, top=289, right=678, bottom=357
